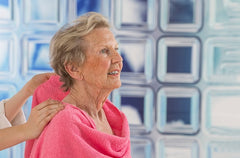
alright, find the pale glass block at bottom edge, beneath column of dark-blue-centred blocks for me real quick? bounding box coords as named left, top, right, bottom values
left=156, top=138, right=200, bottom=158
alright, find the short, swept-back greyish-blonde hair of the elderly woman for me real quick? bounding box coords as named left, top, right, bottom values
left=49, top=12, right=110, bottom=91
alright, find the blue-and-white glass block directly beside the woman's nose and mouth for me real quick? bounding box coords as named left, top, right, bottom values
left=117, top=37, right=153, bottom=84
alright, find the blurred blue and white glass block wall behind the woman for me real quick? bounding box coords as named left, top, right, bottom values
left=0, top=0, right=240, bottom=158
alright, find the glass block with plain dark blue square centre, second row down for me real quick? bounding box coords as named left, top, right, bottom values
left=157, top=37, right=200, bottom=83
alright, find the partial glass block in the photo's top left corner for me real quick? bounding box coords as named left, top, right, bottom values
left=0, top=0, right=13, bottom=23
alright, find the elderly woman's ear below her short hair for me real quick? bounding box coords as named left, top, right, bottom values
left=64, top=64, right=83, bottom=80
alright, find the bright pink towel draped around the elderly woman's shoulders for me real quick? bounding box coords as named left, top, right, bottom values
left=25, top=76, right=131, bottom=158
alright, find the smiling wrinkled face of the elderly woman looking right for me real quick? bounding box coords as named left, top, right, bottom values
left=82, top=28, right=122, bottom=90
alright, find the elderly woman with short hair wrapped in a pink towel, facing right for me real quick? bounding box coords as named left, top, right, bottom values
left=25, top=12, right=131, bottom=158
